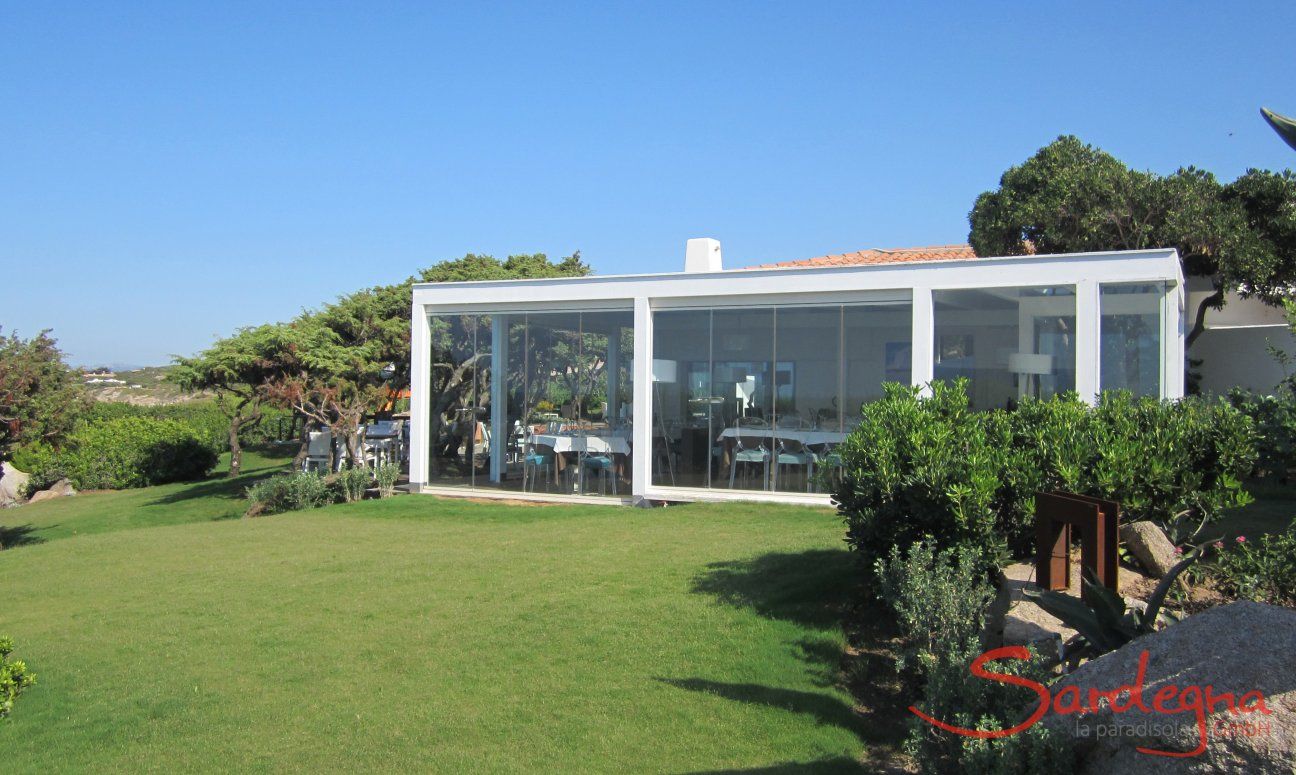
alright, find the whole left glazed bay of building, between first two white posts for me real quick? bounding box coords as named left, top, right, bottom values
left=428, top=310, right=634, bottom=495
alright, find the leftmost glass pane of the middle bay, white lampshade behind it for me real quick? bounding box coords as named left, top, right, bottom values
left=652, top=310, right=715, bottom=487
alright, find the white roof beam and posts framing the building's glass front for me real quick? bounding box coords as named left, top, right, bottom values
left=410, top=250, right=1183, bottom=503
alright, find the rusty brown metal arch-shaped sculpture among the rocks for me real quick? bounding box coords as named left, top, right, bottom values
left=1036, top=492, right=1121, bottom=603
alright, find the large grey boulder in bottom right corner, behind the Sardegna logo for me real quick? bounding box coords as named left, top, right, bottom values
left=1041, top=603, right=1296, bottom=775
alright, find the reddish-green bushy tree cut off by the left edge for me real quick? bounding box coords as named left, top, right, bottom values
left=0, top=330, right=89, bottom=457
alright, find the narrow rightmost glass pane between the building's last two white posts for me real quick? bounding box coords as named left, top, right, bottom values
left=1099, top=283, right=1165, bottom=397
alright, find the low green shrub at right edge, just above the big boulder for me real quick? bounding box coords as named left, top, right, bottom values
left=1214, top=521, right=1296, bottom=608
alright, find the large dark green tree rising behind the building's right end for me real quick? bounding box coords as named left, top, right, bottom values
left=968, top=135, right=1296, bottom=346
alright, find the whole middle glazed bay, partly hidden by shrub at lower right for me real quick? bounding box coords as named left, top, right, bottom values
left=652, top=301, right=912, bottom=492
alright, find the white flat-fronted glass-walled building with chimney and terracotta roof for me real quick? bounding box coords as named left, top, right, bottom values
left=410, top=240, right=1186, bottom=503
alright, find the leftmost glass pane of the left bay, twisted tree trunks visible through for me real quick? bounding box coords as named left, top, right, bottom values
left=428, top=315, right=491, bottom=486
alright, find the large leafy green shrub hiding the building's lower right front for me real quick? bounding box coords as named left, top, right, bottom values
left=833, top=380, right=1255, bottom=568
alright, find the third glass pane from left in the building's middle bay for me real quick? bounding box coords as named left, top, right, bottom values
left=767, top=305, right=842, bottom=492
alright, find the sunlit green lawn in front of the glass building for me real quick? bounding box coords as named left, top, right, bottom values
left=0, top=459, right=876, bottom=772
